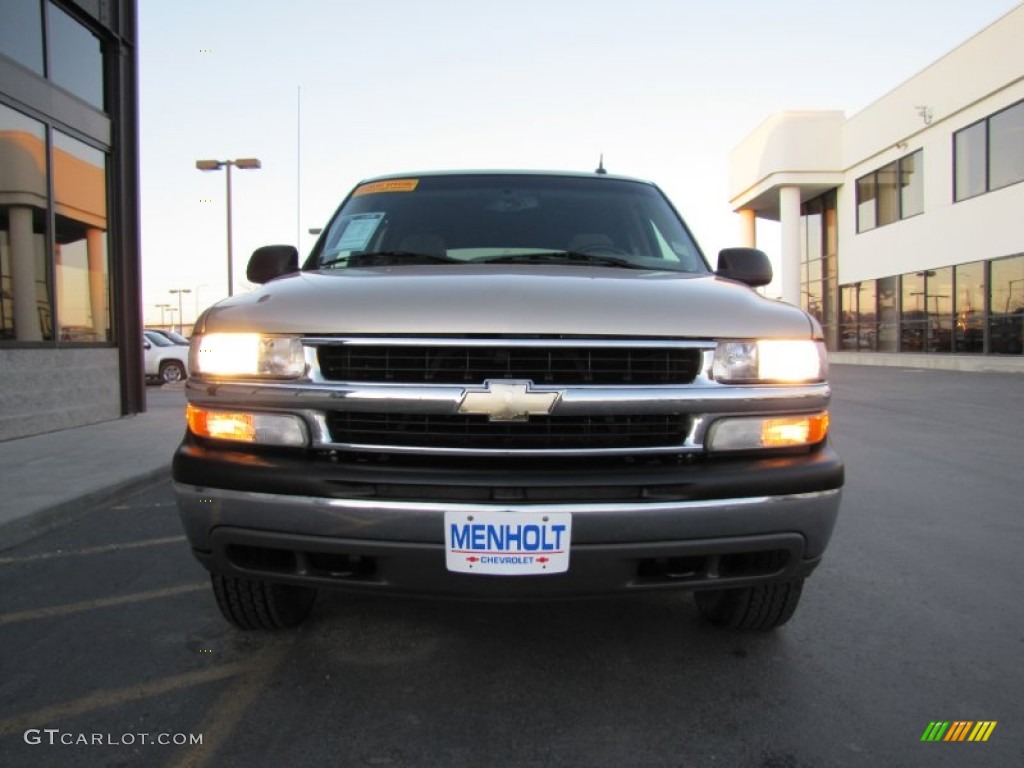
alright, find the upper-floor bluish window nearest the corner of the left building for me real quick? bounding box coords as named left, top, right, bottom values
left=46, top=2, right=103, bottom=110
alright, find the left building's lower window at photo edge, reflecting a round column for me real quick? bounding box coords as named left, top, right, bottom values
left=0, top=104, right=52, bottom=341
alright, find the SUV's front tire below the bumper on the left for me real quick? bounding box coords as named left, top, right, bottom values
left=210, top=573, right=316, bottom=630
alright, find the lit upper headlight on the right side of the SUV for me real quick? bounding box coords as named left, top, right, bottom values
left=713, top=339, right=828, bottom=384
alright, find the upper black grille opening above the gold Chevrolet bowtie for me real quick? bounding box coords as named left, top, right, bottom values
left=317, top=340, right=700, bottom=386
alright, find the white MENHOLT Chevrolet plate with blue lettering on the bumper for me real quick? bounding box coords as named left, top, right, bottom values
left=444, top=512, right=572, bottom=575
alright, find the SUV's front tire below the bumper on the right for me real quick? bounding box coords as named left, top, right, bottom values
left=693, top=579, right=804, bottom=630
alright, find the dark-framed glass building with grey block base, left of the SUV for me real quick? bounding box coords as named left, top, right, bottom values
left=0, top=0, right=145, bottom=439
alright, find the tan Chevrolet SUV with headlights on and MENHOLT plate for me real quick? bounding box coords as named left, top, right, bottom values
left=173, top=172, right=843, bottom=630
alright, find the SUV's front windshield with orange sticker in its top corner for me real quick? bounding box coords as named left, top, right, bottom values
left=306, top=174, right=708, bottom=273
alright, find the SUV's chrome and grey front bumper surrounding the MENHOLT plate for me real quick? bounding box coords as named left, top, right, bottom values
left=175, top=482, right=841, bottom=599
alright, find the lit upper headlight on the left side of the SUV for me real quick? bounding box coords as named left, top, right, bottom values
left=188, top=334, right=306, bottom=379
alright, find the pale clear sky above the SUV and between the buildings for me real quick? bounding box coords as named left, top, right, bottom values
left=138, top=0, right=1020, bottom=325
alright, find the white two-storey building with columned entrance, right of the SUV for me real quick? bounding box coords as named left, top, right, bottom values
left=729, top=6, right=1024, bottom=371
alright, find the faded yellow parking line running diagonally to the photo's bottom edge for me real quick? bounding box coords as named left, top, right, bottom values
left=164, top=635, right=290, bottom=768
